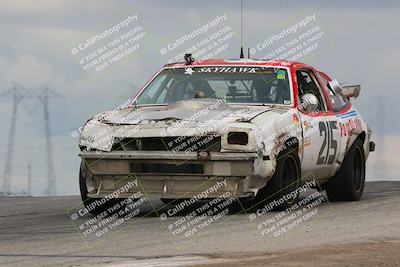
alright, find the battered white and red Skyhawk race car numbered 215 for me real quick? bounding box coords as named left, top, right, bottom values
left=79, top=56, right=375, bottom=213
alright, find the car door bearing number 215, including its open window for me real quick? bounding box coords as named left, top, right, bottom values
left=296, top=68, right=340, bottom=180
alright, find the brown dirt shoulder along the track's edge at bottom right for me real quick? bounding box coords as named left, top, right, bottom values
left=194, top=239, right=400, bottom=267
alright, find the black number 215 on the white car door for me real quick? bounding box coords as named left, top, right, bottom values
left=317, top=121, right=337, bottom=165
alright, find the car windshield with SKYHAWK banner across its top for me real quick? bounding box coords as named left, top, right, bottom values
left=137, top=66, right=291, bottom=105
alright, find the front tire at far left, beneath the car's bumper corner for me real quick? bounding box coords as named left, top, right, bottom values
left=79, top=160, right=119, bottom=215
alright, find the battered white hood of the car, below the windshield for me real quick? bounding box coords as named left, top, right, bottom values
left=97, top=99, right=284, bottom=125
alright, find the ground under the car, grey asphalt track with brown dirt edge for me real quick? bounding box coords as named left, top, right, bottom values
left=0, top=182, right=400, bottom=267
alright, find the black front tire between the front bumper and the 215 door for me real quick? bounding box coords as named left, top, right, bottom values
left=255, top=147, right=301, bottom=210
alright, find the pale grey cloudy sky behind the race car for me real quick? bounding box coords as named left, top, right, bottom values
left=0, top=0, right=400, bottom=195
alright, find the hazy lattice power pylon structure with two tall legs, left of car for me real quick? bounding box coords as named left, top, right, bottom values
left=0, top=83, right=63, bottom=195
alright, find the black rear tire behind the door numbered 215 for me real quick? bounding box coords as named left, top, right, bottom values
left=326, top=139, right=365, bottom=201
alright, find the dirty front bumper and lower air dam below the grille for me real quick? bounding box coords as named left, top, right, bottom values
left=80, top=151, right=259, bottom=199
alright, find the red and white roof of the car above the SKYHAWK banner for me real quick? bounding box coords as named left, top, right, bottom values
left=164, top=58, right=312, bottom=68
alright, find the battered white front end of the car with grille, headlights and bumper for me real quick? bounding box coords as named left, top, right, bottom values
left=80, top=121, right=273, bottom=198
